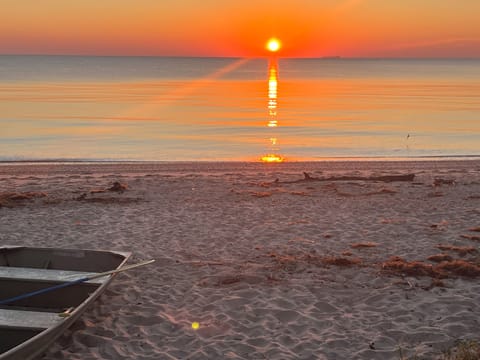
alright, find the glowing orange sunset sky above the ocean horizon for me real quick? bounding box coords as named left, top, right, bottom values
left=0, top=0, right=480, bottom=57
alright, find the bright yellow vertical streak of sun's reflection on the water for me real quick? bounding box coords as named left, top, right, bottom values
left=261, top=58, right=284, bottom=162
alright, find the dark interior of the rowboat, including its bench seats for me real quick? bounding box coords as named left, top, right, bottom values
left=0, top=247, right=126, bottom=356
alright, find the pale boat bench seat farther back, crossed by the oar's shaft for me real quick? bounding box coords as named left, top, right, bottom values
left=0, top=266, right=105, bottom=284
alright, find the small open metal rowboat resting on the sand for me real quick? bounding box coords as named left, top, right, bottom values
left=0, top=246, right=132, bottom=360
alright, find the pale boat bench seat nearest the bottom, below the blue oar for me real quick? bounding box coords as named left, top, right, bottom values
left=0, top=309, right=64, bottom=330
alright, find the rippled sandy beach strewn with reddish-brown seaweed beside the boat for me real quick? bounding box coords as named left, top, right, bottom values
left=0, top=160, right=480, bottom=360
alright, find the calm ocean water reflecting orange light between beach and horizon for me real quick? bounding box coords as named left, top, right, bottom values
left=0, top=56, right=480, bottom=161
